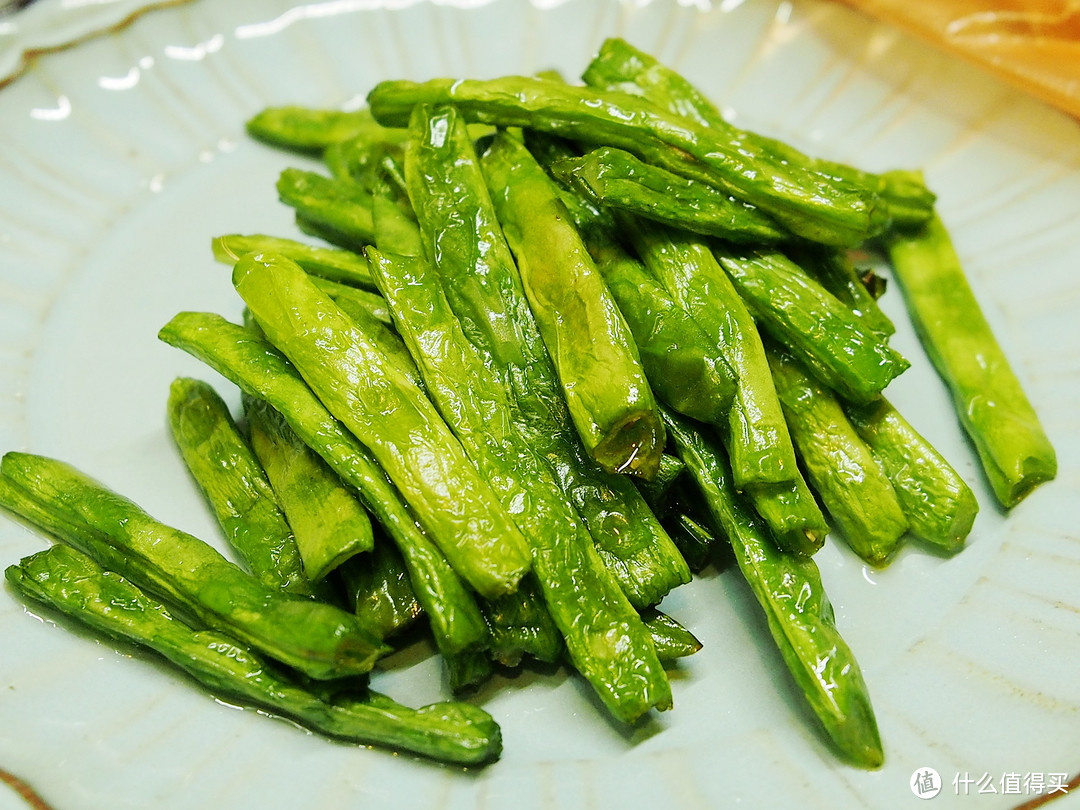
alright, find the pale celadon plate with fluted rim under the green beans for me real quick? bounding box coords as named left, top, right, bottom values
left=0, top=0, right=1080, bottom=810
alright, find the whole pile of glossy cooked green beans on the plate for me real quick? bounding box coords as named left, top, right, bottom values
left=0, top=39, right=1056, bottom=768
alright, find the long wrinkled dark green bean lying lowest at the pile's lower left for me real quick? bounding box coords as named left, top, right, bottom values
left=5, top=545, right=502, bottom=765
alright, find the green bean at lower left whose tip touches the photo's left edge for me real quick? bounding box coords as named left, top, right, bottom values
left=0, top=453, right=389, bottom=679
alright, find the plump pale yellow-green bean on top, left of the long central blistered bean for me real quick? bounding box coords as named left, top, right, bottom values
left=233, top=254, right=531, bottom=597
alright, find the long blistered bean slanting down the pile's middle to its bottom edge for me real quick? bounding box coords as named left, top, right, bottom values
left=368, top=247, right=671, bottom=721
